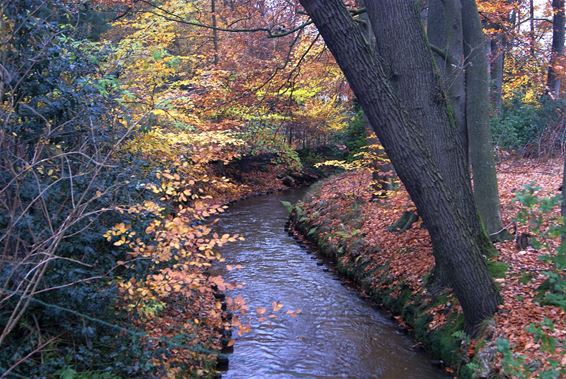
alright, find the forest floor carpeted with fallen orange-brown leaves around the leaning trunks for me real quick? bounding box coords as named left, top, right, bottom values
left=302, top=159, right=566, bottom=377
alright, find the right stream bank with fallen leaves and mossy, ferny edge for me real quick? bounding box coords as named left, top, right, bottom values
left=287, top=176, right=495, bottom=378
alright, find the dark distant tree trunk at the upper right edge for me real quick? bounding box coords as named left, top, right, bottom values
left=547, top=0, right=566, bottom=99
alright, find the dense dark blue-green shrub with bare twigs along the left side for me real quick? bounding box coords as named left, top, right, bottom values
left=0, top=0, right=153, bottom=377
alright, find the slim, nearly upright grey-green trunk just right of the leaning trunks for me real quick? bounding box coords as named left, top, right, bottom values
left=461, top=0, right=507, bottom=239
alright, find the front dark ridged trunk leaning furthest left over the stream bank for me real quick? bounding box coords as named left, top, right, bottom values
left=301, top=0, right=498, bottom=332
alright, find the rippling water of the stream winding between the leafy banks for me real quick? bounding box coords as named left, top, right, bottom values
left=219, top=190, right=445, bottom=379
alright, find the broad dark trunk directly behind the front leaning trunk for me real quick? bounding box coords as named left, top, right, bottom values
left=366, top=0, right=481, bottom=235
